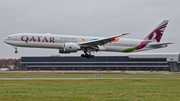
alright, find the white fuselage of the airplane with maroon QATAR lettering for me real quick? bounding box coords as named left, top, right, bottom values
left=4, top=33, right=166, bottom=52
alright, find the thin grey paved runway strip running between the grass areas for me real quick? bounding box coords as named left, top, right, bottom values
left=0, top=78, right=180, bottom=80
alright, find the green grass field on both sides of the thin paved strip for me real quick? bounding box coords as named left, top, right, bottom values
left=0, top=74, right=180, bottom=101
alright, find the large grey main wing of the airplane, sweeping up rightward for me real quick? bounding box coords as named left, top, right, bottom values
left=79, top=33, right=130, bottom=47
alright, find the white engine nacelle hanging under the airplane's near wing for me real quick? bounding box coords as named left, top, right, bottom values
left=59, top=43, right=80, bottom=53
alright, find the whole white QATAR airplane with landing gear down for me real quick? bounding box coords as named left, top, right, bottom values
left=3, top=20, right=172, bottom=59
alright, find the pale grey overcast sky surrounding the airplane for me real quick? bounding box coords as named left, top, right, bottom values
left=0, top=0, right=180, bottom=59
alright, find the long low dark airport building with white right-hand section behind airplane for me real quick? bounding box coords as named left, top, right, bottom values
left=21, top=53, right=180, bottom=71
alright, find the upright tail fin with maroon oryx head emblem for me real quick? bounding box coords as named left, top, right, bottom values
left=144, top=20, right=169, bottom=42
